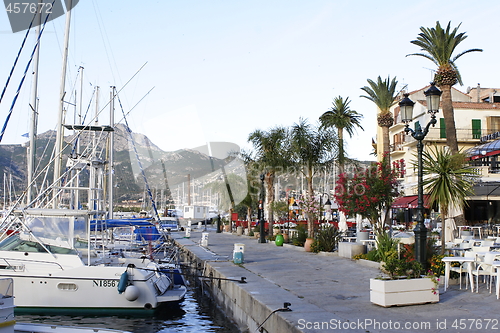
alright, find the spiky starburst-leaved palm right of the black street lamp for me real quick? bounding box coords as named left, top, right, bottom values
left=422, top=146, right=478, bottom=253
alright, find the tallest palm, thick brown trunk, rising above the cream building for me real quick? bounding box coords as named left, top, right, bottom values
left=407, top=22, right=483, bottom=153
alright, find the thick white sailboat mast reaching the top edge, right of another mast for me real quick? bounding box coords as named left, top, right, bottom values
left=53, top=0, right=73, bottom=208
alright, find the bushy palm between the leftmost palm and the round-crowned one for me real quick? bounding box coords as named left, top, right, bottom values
left=290, top=119, right=338, bottom=238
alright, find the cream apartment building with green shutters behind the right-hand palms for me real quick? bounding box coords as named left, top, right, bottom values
left=388, top=85, right=500, bottom=224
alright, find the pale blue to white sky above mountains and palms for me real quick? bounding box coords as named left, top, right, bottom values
left=0, top=0, right=500, bottom=160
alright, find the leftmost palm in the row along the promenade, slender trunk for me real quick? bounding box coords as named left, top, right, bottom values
left=248, top=127, right=288, bottom=232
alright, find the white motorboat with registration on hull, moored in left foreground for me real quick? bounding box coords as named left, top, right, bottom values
left=0, top=209, right=186, bottom=313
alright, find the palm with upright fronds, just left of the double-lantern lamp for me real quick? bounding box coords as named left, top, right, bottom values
left=360, top=76, right=398, bottom=156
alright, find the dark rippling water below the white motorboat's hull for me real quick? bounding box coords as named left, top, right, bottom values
left=16, top=289, right=240, bottom=333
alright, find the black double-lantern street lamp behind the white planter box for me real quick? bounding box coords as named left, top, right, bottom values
left=399, top=82, right=442, bottom=268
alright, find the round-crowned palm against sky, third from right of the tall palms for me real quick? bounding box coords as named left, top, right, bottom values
left=319, top=96, right=364, bottom=174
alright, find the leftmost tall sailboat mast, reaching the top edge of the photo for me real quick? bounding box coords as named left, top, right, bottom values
left=26, top=0, right=42, bottom=205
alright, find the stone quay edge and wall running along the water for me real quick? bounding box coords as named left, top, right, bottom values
left=176, top=239, right=304, bottom=333
